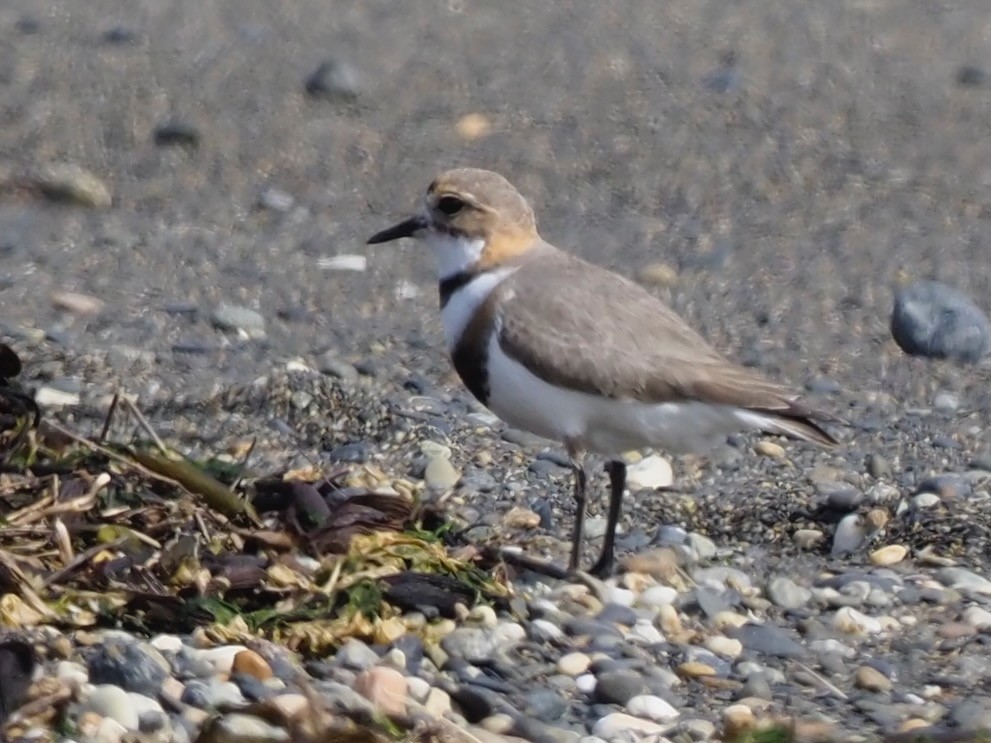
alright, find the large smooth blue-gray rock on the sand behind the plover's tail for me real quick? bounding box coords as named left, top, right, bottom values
left=891, top=281, right=991, bottom=363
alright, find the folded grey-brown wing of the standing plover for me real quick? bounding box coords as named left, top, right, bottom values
left=499, top=246, right=836, bottom=443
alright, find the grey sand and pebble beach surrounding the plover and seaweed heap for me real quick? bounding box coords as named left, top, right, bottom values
left=0, top=0, right=991, bottom=743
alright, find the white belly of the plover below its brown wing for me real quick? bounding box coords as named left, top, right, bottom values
left=488, top=336, right=762, bottom=457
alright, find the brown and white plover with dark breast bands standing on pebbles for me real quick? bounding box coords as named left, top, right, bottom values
left=368, top=168, right=839, bottom=576
